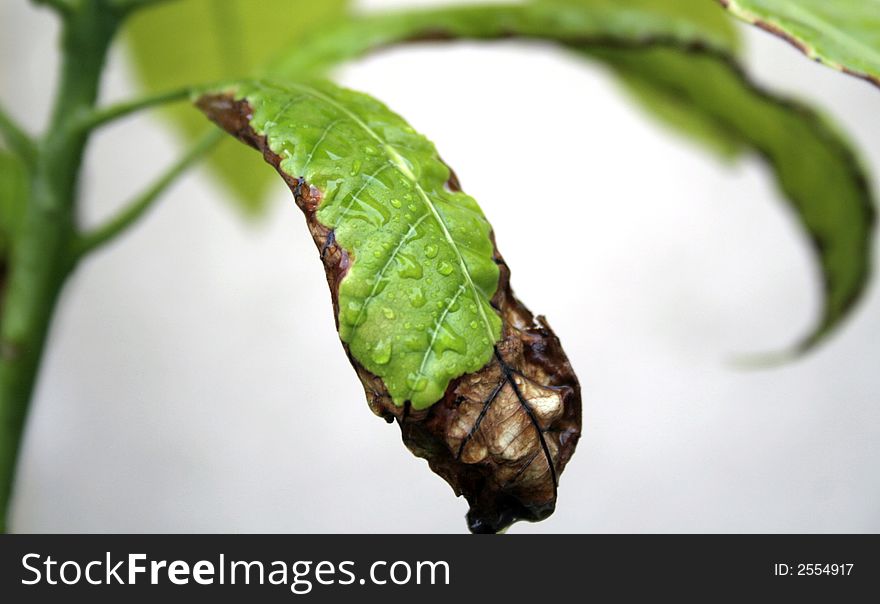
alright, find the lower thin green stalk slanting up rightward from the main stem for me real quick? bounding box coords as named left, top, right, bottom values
left=74, top=129, right=224, bottom=258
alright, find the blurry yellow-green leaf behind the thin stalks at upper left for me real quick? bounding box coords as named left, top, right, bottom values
left=126, top=0, right=348, bottom=213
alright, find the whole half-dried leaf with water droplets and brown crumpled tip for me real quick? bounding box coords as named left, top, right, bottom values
left=196, top=81, right=580, bottom=532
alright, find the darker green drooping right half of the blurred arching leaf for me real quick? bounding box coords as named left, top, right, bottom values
left=592, top=48, right=875, bottom=351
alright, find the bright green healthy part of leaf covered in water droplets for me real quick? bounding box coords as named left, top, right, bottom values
left=218, top=82, right=501, bottom=409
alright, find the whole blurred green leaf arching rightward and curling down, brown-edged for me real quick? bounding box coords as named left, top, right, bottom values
left=273, top=3, right=874, bottom=351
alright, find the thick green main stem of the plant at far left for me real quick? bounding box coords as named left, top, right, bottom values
left=0, top=0, right=122, bottom=532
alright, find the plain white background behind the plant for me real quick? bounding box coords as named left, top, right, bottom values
left=0, top=0, right=880, bottom=533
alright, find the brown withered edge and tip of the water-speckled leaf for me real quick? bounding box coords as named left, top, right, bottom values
left=196, top=94, right=581, bottom=533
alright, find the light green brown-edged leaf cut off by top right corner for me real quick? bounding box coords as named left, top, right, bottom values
left=720, top=0, right=880, bottom=86
